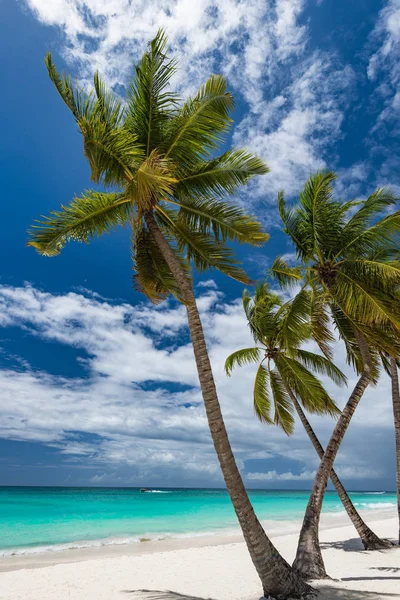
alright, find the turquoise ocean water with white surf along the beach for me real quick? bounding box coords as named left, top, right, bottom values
left=0, top=487, right=396, bottom=556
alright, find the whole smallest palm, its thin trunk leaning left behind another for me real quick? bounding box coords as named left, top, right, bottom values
left=225, top=283, right=388, bottom=550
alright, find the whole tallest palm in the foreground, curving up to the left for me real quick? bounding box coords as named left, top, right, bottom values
left=29, top=31, right=310, bottom=599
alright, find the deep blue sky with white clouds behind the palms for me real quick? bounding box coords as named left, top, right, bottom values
left=0, top=0, right=400, bottom=489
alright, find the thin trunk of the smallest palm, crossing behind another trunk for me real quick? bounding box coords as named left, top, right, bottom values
left=286, top=387, right=387, bottom=550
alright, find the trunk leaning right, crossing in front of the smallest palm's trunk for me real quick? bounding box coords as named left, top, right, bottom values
left=293, top=331, right=391, bottom=579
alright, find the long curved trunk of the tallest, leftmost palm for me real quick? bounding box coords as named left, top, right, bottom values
left=145, top=213, right=312, bottom=600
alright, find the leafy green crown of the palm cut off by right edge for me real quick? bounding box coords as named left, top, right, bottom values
left=271, top=172, right=400, bottom=372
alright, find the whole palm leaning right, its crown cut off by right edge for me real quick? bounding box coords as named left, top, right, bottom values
left=271, top=173, right=400, bottom=579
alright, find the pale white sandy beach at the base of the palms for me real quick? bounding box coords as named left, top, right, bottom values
left=0, top=510, right=400, bottom=600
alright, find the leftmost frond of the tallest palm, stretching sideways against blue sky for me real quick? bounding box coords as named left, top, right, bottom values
left=28, top=190, right=132, bottom=256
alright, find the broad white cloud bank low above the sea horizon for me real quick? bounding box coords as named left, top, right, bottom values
left=0, top=285, right=392, bottom=485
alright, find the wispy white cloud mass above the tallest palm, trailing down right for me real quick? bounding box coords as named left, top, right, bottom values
left=21, top=0, right=354, bottom=201
